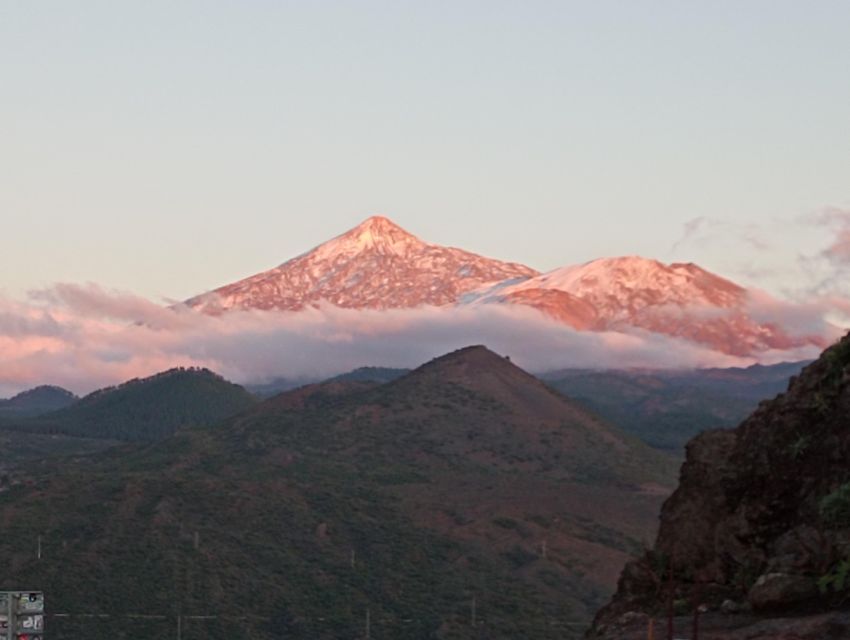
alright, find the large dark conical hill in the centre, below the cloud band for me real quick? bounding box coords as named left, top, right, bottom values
left=0, top=347, right=675, bottom=640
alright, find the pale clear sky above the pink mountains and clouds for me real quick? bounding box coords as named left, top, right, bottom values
left=0, top=0, right=850, bottom=298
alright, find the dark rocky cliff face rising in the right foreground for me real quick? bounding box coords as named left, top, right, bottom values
left=589, top=335, right=850, bottom=639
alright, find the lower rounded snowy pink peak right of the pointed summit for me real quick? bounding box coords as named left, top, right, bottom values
left=479, top=256, right=826, bottom=356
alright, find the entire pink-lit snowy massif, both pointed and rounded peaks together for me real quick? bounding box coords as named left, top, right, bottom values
left=186, top=216, right=827, bottom=357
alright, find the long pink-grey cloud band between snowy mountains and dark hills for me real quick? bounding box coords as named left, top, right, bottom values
left=0, top=284, right=828, bottom=396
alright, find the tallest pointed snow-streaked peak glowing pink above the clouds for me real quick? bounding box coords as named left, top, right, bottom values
left=187, top=216, right=539, bottom=314
